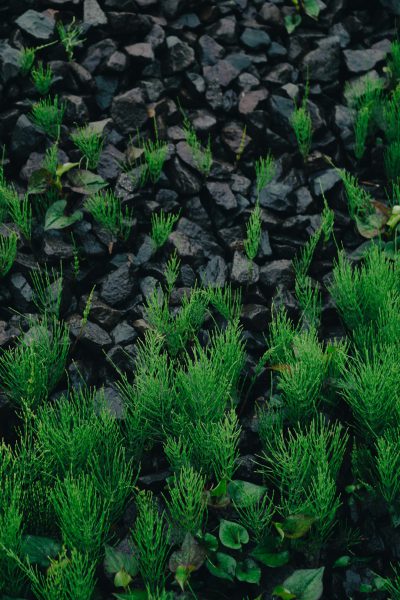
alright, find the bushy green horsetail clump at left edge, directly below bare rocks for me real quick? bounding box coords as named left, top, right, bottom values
left=0, top=317, right=69, bottom=408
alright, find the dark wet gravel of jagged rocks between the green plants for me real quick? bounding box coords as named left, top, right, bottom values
left=0, top=0, right=400, bottom=598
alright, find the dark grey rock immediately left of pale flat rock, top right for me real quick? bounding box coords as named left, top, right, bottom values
left=303, top=36, right=340, bottom=81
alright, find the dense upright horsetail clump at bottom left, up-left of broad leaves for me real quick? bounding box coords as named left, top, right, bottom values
left=50, top=473, right=111, bottom=560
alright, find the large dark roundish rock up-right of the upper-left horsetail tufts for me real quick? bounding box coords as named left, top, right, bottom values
left=111, top=88, right=148, bottom=133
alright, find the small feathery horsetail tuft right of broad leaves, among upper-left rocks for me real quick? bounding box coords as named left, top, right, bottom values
left=84, top=191, right=133, bottom=241
